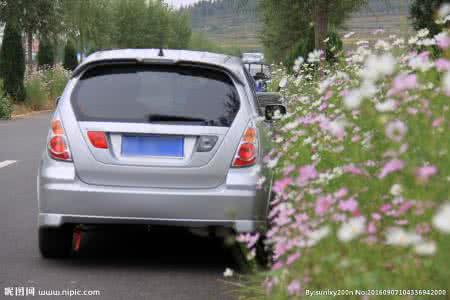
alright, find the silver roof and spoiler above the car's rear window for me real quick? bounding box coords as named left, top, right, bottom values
left=73, top=49, right=243, bottom=79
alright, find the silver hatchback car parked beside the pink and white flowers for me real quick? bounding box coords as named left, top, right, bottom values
left=37, top=49, right=285, bottom=257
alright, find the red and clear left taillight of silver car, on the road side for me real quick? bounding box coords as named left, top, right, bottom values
left=47, top=116, right=72, bottom=161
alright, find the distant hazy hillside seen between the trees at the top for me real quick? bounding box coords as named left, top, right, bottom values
left=183, top=0, right=411, bottom=50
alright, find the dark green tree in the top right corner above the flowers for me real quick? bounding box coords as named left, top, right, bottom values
left=410, top=0, right=450, bottom=35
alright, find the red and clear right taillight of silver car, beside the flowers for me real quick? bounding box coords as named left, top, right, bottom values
left=232, top=125, right=258, bottom=168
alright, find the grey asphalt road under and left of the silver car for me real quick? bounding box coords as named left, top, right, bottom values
left=0, top=113, right=239, bottom=300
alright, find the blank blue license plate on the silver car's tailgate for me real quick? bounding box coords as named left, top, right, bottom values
left=122, top=135, right=184, bottom=157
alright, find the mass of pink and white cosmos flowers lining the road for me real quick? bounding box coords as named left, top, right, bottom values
left=238, top=23, right=450, bottom=300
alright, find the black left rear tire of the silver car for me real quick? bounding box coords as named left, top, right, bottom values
left=38, top=226, right=72, bottom=258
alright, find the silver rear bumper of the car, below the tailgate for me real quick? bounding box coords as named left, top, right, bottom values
left=38, top=159, right=267, bottom=232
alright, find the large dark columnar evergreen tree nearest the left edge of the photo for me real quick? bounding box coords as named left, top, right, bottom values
left=0, top=20, right=25, bottom=101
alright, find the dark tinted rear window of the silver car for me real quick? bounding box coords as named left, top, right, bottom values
left=71, top=65, right=240, bottom=127
